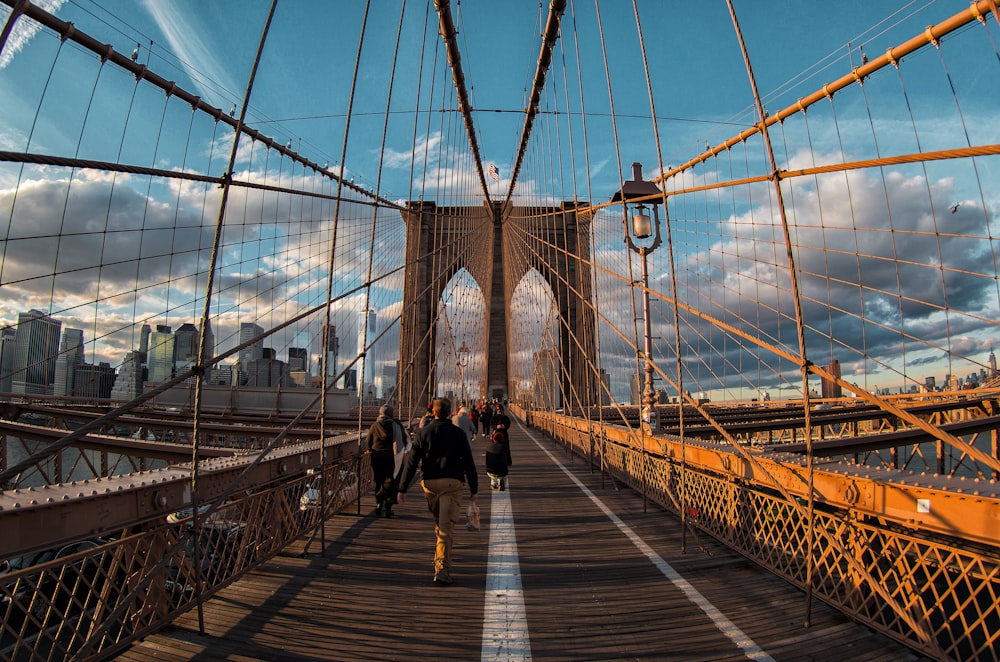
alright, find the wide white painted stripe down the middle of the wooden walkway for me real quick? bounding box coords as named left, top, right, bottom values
left=482, top=483, right=531, bottom=662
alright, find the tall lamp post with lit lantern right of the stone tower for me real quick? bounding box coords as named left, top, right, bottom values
left=611, top=163, right=663, bottom=430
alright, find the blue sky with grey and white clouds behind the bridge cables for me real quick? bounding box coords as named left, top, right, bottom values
left=0, top=0, right=1000, bottom=397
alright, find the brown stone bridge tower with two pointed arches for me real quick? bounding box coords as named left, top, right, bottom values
left=398, top=202, right=598, bottom=415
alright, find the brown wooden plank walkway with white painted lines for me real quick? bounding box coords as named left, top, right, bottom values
left=119, top=422, right=922, bottom=662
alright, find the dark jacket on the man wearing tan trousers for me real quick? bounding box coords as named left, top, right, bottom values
left=399, top=418, right=479, bottom=494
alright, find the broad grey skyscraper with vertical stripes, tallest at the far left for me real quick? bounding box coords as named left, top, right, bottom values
left=10, top=310, right=62, bottom=395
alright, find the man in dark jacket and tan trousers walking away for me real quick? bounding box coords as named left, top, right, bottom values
left=396, top=398, right=479, bottom=585
